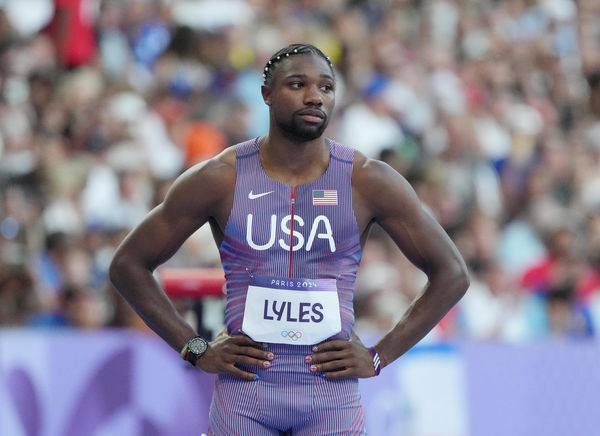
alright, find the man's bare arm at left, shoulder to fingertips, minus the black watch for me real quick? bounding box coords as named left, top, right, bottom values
left=110, top=150, right=275, bottom=380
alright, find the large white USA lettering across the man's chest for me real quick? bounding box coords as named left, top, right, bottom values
left=246, top=214, right=336, bottom=253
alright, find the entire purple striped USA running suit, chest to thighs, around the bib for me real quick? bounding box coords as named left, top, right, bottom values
left=210, top=138, right=365, bottom=436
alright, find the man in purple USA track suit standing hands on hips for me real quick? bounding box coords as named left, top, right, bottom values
left=110, top=44, right=468, bottom=436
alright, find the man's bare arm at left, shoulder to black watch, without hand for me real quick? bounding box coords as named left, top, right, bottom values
left=110, top=158, right=235, bottom=351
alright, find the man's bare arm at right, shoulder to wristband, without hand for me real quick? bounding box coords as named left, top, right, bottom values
left=353, top=159, right=469, bottom=366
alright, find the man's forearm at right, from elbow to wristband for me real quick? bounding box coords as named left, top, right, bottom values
left=375, top=272, right=468, bottom=367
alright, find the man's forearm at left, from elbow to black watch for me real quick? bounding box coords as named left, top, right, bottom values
left=110, top=258, right=196, bottom=351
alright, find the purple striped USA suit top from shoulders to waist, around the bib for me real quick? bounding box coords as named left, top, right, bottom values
left=217, top=140, right=365, bottom=337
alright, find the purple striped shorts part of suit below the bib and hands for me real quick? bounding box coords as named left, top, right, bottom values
left=209, top=344, right=366, bottom=436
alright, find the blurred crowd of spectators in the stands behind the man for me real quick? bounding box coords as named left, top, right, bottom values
left=0, top=0, right=600, bottom=342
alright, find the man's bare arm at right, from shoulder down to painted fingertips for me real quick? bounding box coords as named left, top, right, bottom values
left=306, top=156, right=469, bottom=378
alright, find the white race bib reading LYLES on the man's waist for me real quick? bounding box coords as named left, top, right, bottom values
left=242, top=277, right=342, bottom=345
